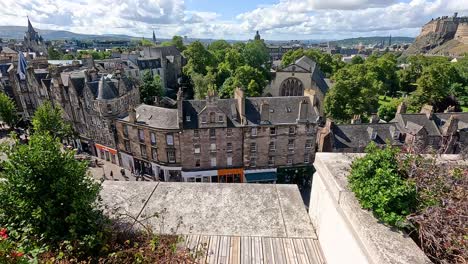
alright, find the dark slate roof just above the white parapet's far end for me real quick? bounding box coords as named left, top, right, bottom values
left=332, top=123, right=402, bottom=149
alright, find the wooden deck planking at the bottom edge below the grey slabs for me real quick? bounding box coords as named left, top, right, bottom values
left=183, top=235, right=325, bottom=264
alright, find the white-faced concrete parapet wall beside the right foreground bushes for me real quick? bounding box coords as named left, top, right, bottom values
left=309, top=152, right=431, bottom=264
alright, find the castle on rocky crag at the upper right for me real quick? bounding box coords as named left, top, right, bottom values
left=418, top=13, right=468, bottom=44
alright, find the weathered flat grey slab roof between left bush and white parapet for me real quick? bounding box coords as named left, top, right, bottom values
left=101, top=181, right=316, bottom=238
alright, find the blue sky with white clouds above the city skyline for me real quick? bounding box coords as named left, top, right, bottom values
left=0, top=0, right=468, bottom=40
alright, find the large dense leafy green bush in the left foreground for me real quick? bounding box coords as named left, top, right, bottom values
left=0, top=134, right=104, bottom=250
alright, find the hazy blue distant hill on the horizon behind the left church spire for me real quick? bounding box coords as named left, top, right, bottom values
left=0, top=26, right=134, bottom=40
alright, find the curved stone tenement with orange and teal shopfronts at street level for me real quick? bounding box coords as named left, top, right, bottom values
left=116, top=89, right=319, bottom=182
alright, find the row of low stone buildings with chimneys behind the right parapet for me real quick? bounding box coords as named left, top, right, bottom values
left=317, top=103, right=468, bottom=154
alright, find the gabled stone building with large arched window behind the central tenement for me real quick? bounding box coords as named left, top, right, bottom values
left=264, top=56, right=328, bottom=113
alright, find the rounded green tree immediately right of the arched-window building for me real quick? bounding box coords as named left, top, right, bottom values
left=324, top=64, right=382, bottom=122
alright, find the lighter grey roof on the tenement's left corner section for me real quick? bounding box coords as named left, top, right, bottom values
left=122, top=104, right=179, bottom=129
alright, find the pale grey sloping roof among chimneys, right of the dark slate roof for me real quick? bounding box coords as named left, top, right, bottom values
left=390, top=114, right=441, bottom=136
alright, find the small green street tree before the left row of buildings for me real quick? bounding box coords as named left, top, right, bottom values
left=32, top=102, right=73, bottom=139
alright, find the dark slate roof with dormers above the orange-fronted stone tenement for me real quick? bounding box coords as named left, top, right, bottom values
left=183, top=96, right=319, bottom=129
